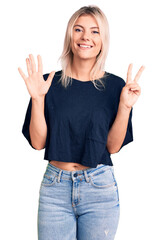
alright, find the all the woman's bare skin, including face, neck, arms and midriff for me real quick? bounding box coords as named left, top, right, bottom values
left=18, top=15, right=145, bottom=171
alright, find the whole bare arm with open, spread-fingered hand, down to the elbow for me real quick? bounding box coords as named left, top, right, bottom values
left=18, top=54, right=55, bottom=150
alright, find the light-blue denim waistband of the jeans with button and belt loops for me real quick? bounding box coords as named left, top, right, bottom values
left=47, top=162, right=113, bottom=182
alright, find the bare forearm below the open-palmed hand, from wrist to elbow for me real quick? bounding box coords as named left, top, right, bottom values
left=29, top=97, right=47, bottom=150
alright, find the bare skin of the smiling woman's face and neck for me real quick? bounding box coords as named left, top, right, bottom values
left=66, top=15, right=104, bottom=81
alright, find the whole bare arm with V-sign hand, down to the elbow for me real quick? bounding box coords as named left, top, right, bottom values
left=106, top=64, right=145, bottom=153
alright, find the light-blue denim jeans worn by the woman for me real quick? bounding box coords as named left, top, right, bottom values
left=38, top=163, right=120, bottom=240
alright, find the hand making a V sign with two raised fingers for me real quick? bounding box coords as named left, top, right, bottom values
left=120, top=64, right=145, bottom=109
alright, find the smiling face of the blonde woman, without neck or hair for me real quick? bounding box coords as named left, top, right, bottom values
left=71, top=15, right=102, bottom=60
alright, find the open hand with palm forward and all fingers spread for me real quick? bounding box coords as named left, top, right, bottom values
left=18, top=54, right=55, bottom=99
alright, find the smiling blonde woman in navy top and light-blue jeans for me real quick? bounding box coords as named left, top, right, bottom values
left=18, top=6, right=144, bottom=240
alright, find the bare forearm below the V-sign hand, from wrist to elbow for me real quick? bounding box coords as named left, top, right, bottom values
left=106, top=103, right=131, bottom=153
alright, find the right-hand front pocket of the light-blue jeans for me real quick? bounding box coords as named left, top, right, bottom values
left=89, top=168, right=116, bottom=189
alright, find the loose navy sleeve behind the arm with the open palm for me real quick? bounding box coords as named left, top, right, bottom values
left=22, top=74, right=47, bottom=149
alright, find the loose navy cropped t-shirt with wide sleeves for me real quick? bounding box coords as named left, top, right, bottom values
left=22, top=71, right=133, bottom=168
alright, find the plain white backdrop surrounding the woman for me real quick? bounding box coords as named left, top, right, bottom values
left=0, top=0, right=163, bottom=240
